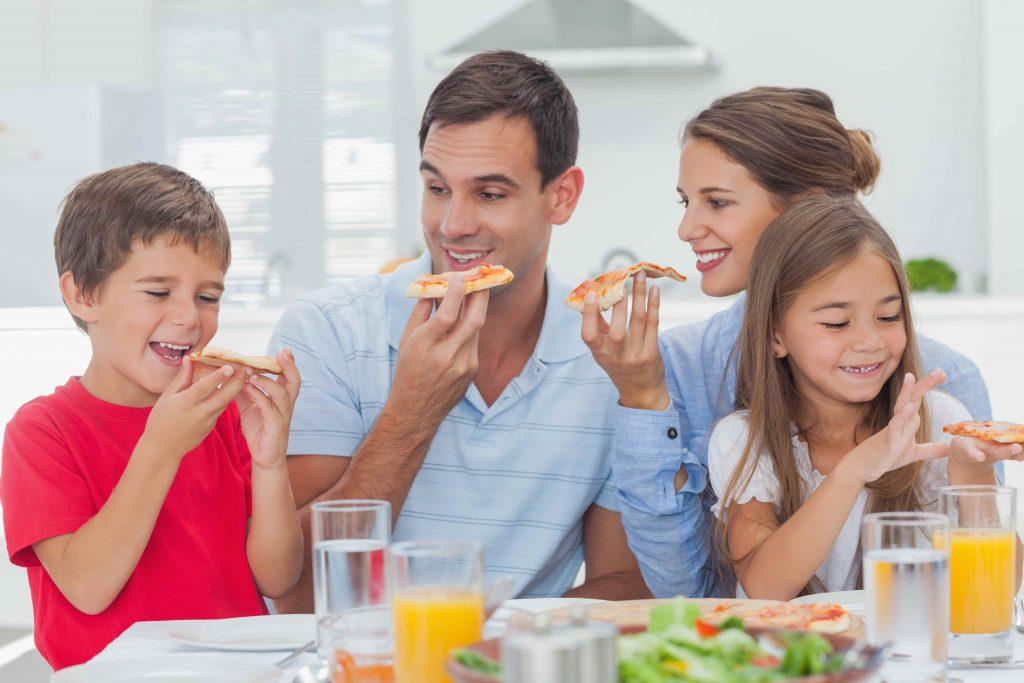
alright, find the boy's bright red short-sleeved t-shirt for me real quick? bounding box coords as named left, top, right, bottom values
left=0, top=378, right=266, bottom=669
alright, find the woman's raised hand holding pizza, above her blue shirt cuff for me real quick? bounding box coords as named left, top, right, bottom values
left=583, top=271, right=671, bottom=411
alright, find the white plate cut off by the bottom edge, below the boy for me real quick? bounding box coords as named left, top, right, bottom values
left=50, top=653, right=282, bottom=683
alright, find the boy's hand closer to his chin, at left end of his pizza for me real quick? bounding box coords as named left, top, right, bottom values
left=139, top=354, right=252, bottom=459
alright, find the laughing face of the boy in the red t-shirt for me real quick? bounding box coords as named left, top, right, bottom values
left=72, top=236, right=224, bottom=405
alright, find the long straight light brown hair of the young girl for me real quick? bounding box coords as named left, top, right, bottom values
left=720, top=195, right=930, bottom=593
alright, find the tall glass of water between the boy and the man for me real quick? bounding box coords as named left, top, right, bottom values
left=311, top=500, right=394, bottom=682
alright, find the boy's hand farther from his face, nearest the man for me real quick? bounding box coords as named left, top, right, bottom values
left=237, top=349, right=302, bottom=469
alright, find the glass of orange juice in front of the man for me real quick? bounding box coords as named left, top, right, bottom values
left=391, top=541, right=483, bottom=683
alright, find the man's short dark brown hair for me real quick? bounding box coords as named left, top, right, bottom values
left=420, top=50, right=580, bottom=187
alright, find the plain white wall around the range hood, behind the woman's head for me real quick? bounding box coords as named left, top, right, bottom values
left=411, top=0, right=991, bottom=291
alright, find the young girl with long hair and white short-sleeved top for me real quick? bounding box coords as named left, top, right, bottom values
left=708, top=195, right=1022, bottom=600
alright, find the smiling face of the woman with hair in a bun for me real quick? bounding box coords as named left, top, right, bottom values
left=676, top=138, right=780, bottom=296
